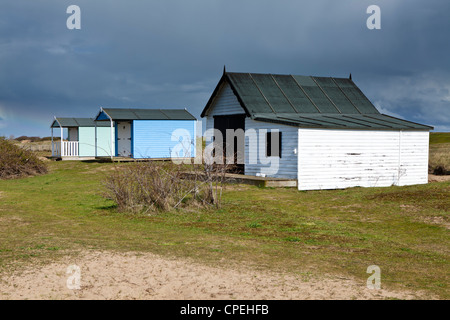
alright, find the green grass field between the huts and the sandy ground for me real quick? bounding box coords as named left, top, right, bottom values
left=0, top=161, right=450, bottom=299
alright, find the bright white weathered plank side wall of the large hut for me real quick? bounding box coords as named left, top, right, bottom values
left=298, top=129, right=429, bottom=190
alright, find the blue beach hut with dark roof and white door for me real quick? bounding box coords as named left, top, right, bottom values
left=95, top=108, right=197, bottom=159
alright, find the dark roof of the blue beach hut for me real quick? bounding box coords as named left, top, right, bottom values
left=95, top=108, right=197, bottom=121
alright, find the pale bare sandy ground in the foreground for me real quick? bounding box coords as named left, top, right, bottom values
left=0, top=252, right=419, bottom=300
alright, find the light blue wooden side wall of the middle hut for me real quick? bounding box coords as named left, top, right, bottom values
left=132, top=120, right=196, bottom=159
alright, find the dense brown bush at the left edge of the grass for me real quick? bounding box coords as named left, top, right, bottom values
left=0, top=137, right=47, bottom=179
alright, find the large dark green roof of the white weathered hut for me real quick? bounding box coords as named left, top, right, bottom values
left=201, top=72, right=433, bottom=130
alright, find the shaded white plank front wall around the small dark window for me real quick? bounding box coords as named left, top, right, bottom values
left=245, top=118, right=298, bottom=179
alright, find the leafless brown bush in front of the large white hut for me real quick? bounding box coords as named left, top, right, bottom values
left=105, top=161, right=234, bottom=213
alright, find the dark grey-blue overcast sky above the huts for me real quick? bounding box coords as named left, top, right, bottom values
left=0, top=0, right=450, bottom=137
